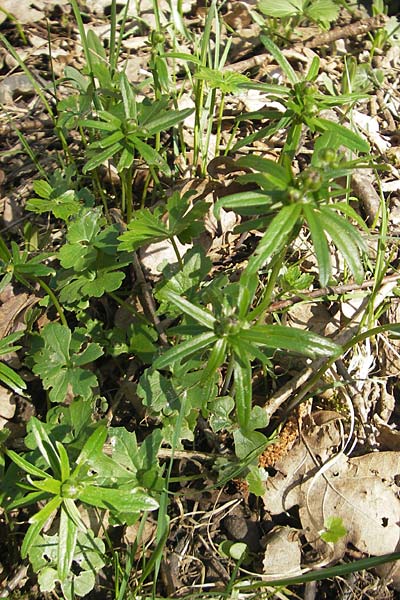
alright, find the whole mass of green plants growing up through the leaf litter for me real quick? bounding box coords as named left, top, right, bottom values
left=0, top=0, right=398, bottom=599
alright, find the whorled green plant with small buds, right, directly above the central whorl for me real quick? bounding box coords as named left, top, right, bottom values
left=215, top=152, right=368, bottom=288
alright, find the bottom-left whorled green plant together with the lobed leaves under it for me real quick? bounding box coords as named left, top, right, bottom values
left=2, top=414, right=160, bottom=599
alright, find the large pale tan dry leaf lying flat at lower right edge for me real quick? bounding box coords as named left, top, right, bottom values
left=299, top=452, right=400, bottom=562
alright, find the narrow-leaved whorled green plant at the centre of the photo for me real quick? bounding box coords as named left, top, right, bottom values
left=153, top=282, right=340, bottom=434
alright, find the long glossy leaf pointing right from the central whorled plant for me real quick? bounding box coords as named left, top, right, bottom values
left=240, top=325, right=341, bottom=358
